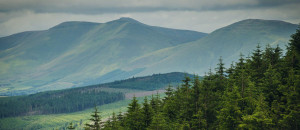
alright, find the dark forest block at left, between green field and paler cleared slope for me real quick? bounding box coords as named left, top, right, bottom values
left=0, top=88, right=125, bottom=118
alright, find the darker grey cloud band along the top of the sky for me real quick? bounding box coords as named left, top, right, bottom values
left=0, top=0, right=300, bottom=14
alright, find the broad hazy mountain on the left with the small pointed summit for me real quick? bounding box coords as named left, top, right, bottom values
left=0, top=18, right=207, bottom=95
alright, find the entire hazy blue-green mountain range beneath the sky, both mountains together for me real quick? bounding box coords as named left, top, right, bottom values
left=0, top=18, right=297, bottom=95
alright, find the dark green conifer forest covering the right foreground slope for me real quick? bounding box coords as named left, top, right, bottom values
left=81, top=25, right=300, bottom=130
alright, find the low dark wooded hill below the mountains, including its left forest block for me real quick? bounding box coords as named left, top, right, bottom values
left=0, top=72, right=193, bottom=118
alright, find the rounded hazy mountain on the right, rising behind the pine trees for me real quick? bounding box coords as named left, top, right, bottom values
left=123, top=19, right=297, bottom=75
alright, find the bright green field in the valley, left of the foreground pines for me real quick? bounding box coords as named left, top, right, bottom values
left=0, top=93, right=164, bottom=130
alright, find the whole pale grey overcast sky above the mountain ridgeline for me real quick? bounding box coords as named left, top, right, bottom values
left=0, top=0, right=300, bottom=36
